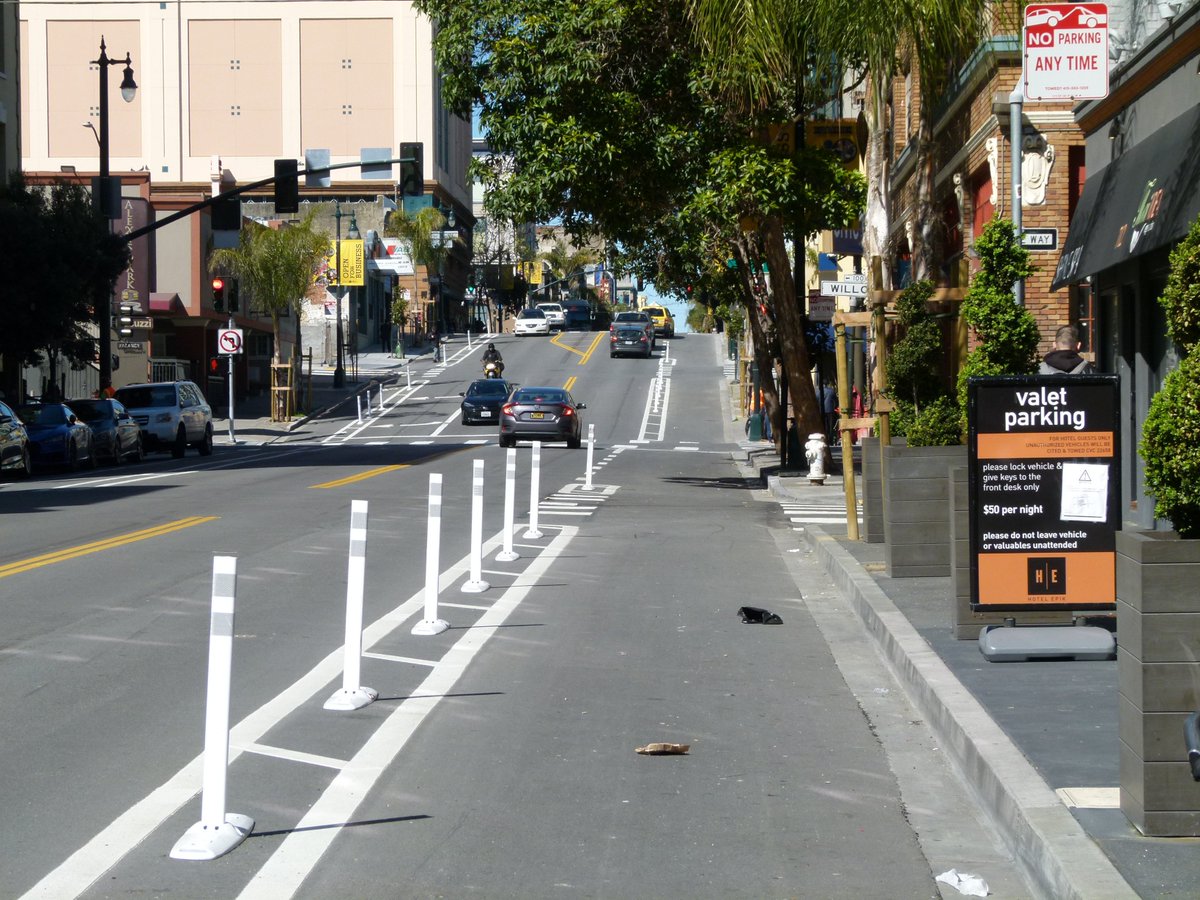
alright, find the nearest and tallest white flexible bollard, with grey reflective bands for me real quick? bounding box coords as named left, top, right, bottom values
left=170, top=557, right=254, bottom=859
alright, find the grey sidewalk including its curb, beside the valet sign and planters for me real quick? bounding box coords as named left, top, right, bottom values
left=742, top=444, right=1200, bottom=900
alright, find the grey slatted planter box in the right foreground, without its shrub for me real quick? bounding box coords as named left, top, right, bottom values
left=1116, top=532, right=1200, bottom=838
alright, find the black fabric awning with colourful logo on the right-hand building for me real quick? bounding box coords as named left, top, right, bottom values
left=1050, top=106, right=1200, bottom=290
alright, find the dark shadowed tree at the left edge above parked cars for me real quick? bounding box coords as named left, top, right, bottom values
left=0, top=176, right=130, bottom=396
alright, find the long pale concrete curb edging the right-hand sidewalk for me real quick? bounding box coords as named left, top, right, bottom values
left=804, top=524, right=1138, bottom=900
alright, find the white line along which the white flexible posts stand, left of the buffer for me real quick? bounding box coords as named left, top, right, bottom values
left=23, top=527, right=577, bottom=900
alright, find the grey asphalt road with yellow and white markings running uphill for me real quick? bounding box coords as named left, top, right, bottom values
left=0, top=334, right=1022, bottom=900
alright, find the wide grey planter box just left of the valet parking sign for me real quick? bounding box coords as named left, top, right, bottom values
left=883, top=444, right=967, bottom=578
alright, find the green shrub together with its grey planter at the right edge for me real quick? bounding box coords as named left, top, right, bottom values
left=1116, top=220, right=1200, bottom=836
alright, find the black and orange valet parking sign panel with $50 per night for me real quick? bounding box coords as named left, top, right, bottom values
left=967, top=376, right=1121, bottom=612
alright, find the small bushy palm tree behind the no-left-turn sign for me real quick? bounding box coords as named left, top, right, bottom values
left=209, top=210, right=329, bottom=420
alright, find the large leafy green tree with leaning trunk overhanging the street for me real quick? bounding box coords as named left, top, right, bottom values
left=418, top=0, right=863, bottom=444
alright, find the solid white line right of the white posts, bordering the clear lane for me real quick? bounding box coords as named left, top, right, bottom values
left=239, top=532, right=574, bottom=900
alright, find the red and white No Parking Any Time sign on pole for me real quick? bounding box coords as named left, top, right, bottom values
left=1024, top=4, right=1109, bottom=100
